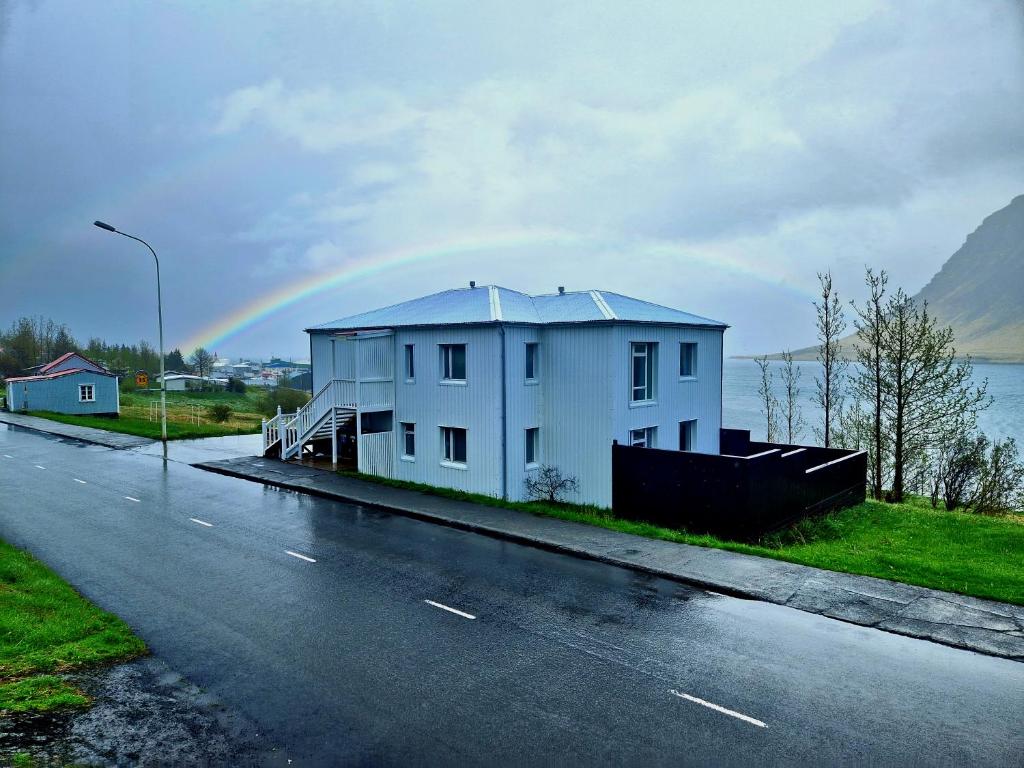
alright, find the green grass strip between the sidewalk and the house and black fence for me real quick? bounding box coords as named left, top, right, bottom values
left=343, top=471, right=1024, bottom=605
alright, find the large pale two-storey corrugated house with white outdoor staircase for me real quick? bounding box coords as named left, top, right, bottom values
left=264, top=284, right=727, bottom=507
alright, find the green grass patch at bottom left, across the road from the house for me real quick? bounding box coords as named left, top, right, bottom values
left=0, top=542, right=146, bottom=712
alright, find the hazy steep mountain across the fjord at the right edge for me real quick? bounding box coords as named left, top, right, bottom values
left=769, top=195, right=1024, bottom=362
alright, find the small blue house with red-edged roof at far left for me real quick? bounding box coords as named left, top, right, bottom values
left=7, top=352, right=121, bottom=416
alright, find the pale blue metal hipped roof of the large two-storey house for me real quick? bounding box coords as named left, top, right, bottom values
left=306, top=286, right=728, bottom=331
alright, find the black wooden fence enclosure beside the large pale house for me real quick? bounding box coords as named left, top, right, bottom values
left=611, top=429, right=867, bottom=540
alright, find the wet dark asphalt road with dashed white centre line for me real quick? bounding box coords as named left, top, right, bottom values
left=0, top=425, right=1024, bottom=767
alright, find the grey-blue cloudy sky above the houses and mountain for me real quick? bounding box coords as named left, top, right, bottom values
left=0, top=0, right=1024, bottom=355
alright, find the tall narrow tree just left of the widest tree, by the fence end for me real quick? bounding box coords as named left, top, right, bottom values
left=853, top=267, right=889, bottom=501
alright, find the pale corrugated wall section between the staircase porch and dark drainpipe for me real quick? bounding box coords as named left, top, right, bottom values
left=394, top=327, right=502, bottom=497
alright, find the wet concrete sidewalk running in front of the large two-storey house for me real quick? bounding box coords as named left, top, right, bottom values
left=195, top=457, right=1024, bottom=660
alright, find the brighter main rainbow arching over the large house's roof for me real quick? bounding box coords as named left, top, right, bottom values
left=180, top=229, right=813, bottom=350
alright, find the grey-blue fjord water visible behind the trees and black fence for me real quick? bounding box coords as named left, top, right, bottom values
left=722, top=359, right=1024, bottom=450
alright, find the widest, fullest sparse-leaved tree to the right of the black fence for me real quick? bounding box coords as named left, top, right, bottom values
left=880, top=289, right=991, bottom=502
